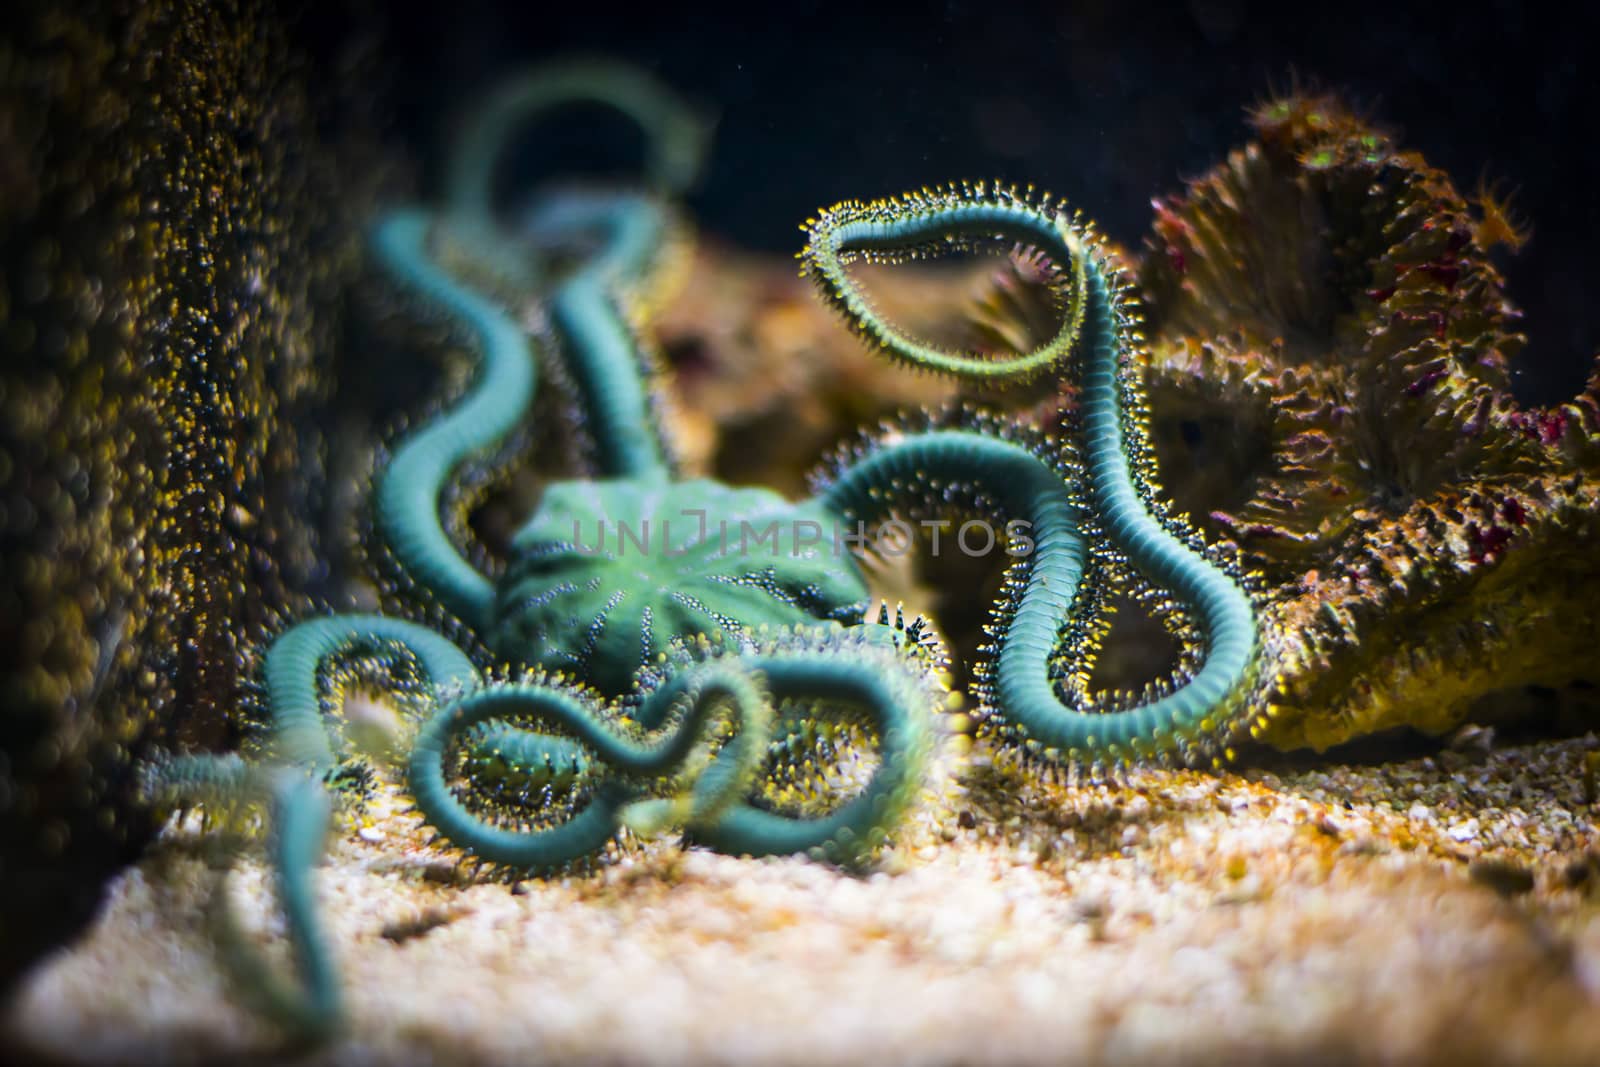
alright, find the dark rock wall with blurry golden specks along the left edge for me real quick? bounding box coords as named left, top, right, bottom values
left=0, top=0, right=366, bottom=982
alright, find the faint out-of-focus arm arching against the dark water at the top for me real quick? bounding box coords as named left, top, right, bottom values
left=446, top=59, right=710, bottom=214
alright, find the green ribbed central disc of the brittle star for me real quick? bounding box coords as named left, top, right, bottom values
left=494, top=478, right=867, bottom=694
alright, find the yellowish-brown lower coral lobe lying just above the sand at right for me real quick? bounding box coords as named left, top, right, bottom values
left=1258, top=475, right=1600, bottom=749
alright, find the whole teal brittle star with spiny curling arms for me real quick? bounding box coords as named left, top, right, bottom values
left=152, top=60, right=1256, bottom=1035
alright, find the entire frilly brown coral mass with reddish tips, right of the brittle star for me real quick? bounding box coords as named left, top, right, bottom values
left=1141, top=94, right=1600, bottom=749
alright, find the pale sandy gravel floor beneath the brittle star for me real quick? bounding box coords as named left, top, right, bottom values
left=5, top=736, right=1600, bottom=1064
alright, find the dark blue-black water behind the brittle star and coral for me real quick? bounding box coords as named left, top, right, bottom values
left=301, top=0, right=1600, bottom=402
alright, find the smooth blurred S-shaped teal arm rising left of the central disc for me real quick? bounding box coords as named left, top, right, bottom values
left=373, top=211, right=538, bottom=629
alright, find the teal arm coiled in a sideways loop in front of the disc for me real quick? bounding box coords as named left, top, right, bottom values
left=411, top=659, right=771, bottom=872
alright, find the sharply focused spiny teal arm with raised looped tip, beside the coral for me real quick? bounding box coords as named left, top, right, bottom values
left=802, top=186, right=1258, bottom=763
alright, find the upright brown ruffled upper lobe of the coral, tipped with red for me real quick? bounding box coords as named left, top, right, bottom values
left=1141, top=96, right=1539, bottom=566
